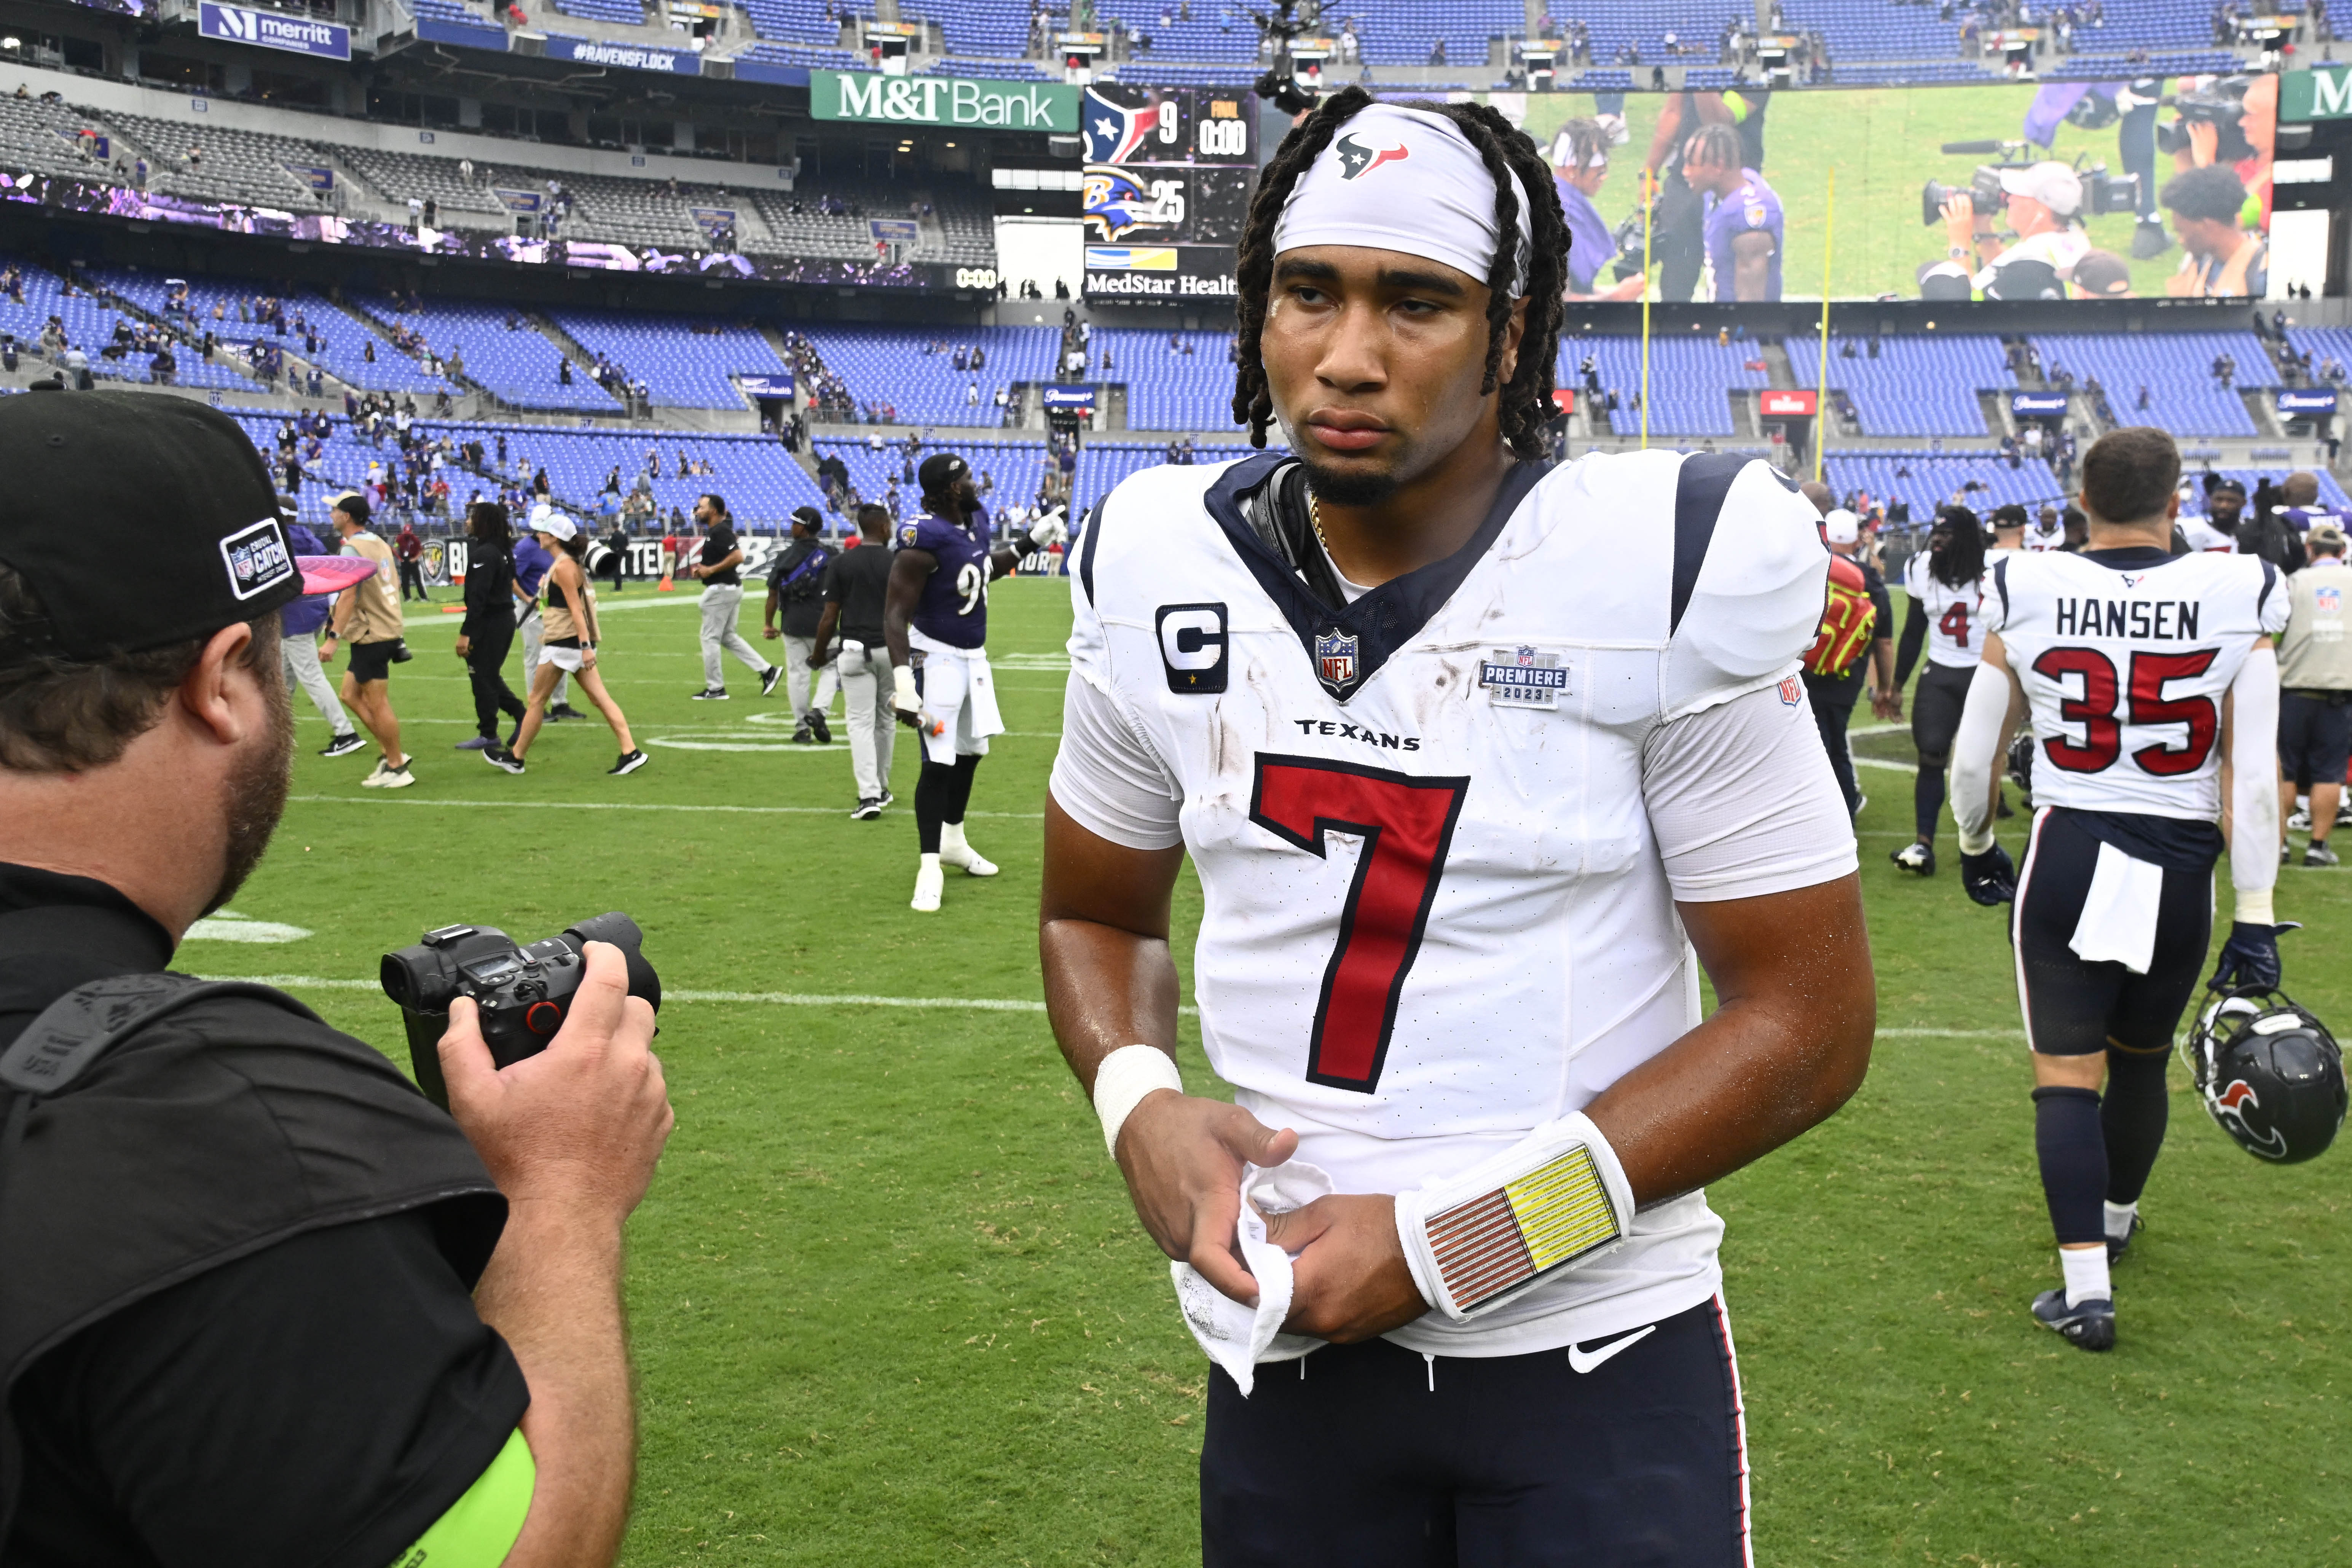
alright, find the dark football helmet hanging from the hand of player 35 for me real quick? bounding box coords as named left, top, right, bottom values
left=2180, top=985, right=2345, bottom=1166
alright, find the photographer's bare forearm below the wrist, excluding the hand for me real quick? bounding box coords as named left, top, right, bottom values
left=475, top=1199, right=638, bottom=1568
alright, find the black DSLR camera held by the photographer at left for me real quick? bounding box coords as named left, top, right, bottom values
left=379, top=910, right=661, bottom=1110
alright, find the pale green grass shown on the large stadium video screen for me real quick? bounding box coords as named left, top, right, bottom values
left=1526, top=84, right=2180, bottom=303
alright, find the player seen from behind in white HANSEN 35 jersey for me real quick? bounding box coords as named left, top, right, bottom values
left=1952, top=425, right=2291, bottom=1350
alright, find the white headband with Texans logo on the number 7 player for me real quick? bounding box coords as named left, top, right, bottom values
left=1275, top=104, right=1529, bottom=296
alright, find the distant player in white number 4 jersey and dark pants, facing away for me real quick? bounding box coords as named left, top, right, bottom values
left=1891, top=505, right=1985, bottom=877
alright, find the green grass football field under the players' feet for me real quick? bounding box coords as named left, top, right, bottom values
left=179, top=578, right=2352, bottom=1568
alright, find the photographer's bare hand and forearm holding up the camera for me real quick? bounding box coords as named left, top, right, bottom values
left=440, top=943, right=673, bottom=1568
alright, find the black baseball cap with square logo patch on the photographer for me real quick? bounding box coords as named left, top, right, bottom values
left=0, top=395, right=303, bottom=658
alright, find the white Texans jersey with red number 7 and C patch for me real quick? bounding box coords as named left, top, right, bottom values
left=1056, top=451, right=1851, bottom=1356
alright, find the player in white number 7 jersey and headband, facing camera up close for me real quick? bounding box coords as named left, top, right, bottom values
left=1040, top=87, right=1875, bottom=1568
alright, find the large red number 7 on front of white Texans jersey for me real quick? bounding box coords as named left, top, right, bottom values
left=1249, top=752, right=1470, bottom=1093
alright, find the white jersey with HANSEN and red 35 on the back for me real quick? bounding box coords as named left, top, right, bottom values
left=1985, top=548, right=2288, bottom=823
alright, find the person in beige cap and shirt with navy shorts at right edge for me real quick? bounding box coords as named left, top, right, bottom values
left=2279, top=519, right=2352, bottom=867
